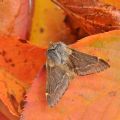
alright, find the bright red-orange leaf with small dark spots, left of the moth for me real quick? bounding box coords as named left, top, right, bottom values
left=0, top=36, right=45, bottom=83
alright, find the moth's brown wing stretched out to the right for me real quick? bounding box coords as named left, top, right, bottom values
left=69, top=49, right=110, bottom=75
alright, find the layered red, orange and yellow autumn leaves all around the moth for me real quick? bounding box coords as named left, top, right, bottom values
left=0, top=0, right=120, bottom=120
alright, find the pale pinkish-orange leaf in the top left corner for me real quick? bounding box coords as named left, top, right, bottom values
left=0, top=0, right=31, bottom=39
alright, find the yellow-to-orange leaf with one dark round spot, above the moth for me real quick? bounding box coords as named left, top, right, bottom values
left=30, top=0, right=75, bottom=48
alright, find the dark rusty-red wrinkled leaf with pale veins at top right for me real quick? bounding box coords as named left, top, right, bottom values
left=52, top=0, right=120, bottom=38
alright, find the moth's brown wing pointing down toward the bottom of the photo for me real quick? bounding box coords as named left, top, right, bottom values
left=46, top=66, right=70, bottom=107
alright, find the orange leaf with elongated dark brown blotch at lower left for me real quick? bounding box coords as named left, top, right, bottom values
left=0, top=68, right=27, bottom=116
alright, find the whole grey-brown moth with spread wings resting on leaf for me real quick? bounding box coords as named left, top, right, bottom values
left=46, top=42, right=110, bottom=107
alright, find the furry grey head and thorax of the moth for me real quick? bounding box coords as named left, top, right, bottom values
left=47, top=42, right=71, bottom=65
